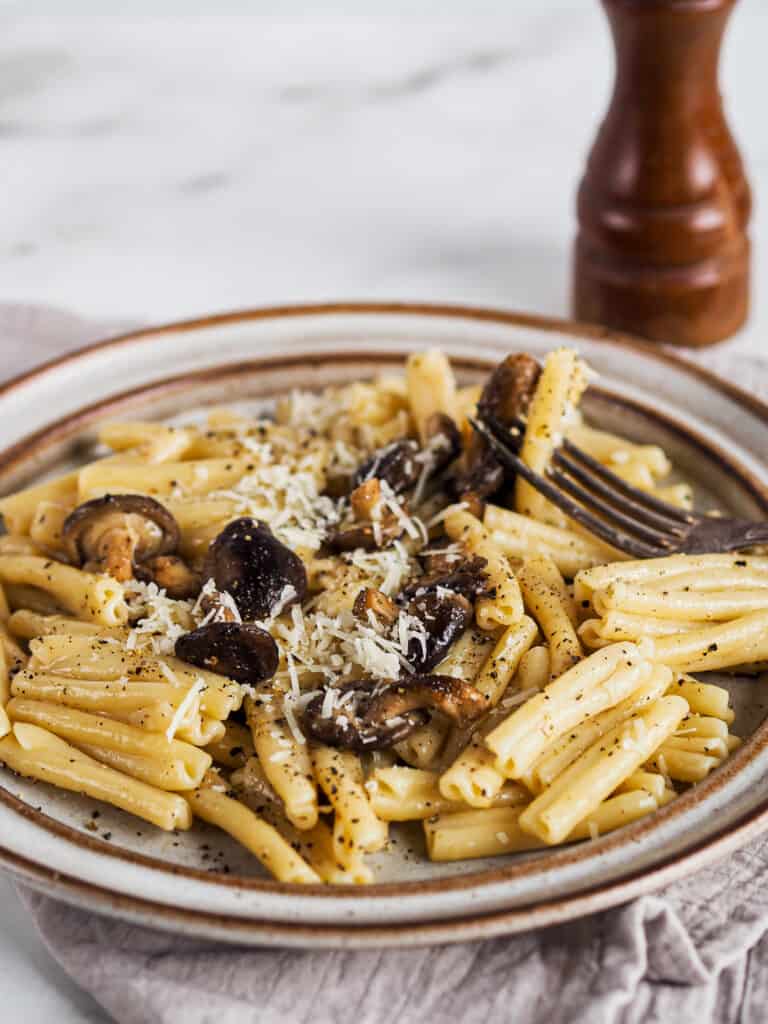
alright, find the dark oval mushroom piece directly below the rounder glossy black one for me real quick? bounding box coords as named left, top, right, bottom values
left=175, top=623, right=280, bottom=685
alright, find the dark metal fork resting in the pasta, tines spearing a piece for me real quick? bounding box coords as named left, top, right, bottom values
left=469, top=414, right=768, bottom=558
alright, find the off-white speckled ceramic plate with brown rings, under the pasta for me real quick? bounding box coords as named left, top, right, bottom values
left=0, top=304, right=768, bottom=948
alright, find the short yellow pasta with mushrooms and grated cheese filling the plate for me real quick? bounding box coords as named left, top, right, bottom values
left=0, top=349, right=753, bottom=885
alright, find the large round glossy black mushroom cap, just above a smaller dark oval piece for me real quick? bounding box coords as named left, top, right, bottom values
left=203, top=516, right=307, bottom=620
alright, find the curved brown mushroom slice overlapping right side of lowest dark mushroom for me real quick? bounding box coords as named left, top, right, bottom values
left=364, top=675, right=487, bottom=726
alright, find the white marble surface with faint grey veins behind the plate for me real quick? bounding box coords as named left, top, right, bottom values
left=0, top=0, right=768, bottom=1024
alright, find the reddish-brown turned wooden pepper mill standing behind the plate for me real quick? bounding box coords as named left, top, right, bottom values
left=573, top=0, right=751, bottom=346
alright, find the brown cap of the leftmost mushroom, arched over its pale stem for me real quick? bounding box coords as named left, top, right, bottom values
left=61, top=495, right=179, bottom=565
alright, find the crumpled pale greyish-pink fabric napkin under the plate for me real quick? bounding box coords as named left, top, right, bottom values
left=0, top=305, right=768, bottom=1024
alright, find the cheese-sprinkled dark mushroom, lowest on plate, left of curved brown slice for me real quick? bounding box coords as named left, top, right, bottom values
left=303, top=682, right=427, bottom=752
